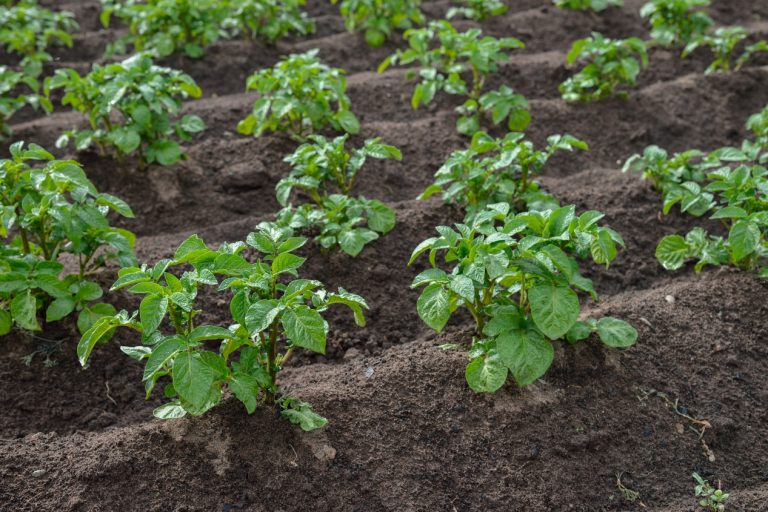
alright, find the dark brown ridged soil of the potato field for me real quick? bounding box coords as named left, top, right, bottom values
left=0, top=0, right=768, bottom=512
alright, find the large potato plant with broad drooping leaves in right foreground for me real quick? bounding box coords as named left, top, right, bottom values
left=409, top=203, right=637, bottom=392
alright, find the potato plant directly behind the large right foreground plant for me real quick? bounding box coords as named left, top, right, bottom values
left=419, top=132, right=588, bottom=219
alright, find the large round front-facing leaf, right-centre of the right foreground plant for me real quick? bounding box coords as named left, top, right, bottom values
left=528, top=283, right=581, bottom=340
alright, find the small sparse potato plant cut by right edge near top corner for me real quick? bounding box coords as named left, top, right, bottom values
left=683, top=27, right=768, bottom=73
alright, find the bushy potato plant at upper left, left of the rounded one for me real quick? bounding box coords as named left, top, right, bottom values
left=45, top=54, right=205, bottom=166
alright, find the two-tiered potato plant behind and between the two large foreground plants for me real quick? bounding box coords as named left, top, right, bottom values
left=277, top=135, right=402, bottom=257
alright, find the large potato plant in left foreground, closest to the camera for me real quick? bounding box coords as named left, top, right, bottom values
left=77, top=225, right=368, bottom=430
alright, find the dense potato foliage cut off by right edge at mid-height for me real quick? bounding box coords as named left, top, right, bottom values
left=624, top=109, right=768, bottom=277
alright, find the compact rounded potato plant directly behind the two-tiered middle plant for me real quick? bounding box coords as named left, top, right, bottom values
left=237, top=49, right=360, bottom=141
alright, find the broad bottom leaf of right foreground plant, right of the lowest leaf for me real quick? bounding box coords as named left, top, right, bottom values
left=496, top=329, right=555, bottom=387
